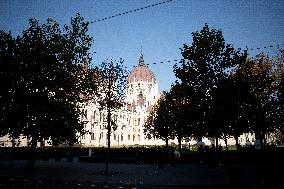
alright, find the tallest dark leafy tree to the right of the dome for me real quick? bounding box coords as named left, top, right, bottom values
left=174, top=24, right=246, bottom=145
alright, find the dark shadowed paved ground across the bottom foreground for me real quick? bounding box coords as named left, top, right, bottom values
left=0, top=159, right=284, bottom=189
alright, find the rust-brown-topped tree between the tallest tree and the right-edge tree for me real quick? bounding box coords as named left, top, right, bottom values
left=235, top=54, right=277, bottom=146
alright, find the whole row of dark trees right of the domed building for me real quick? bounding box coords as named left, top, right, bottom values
left=145, top=24, right=284, bottom=153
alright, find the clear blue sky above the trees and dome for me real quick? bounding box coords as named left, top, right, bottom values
left=0, top=0, right=284, bottom=91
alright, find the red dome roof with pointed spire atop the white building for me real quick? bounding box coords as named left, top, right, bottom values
left=128, top=54, right=156, bottom=82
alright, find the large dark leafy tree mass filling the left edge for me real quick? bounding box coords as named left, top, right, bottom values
left=0, top=14, right=96, bottom=166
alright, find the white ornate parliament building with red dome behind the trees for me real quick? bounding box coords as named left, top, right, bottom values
left=0, top=53, right=254, bottom=147
